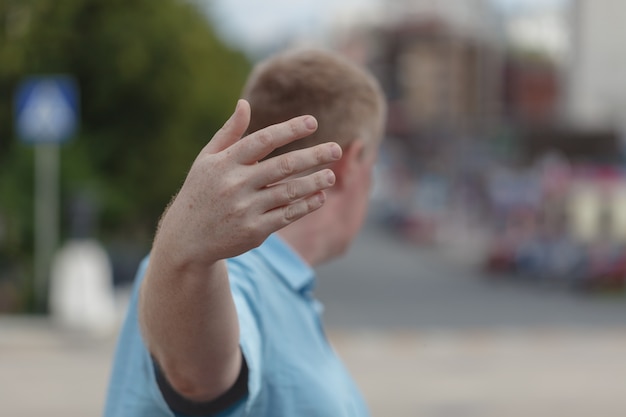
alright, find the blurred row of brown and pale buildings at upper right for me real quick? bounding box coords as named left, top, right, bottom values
left=334, top=0, right=626, bottom=164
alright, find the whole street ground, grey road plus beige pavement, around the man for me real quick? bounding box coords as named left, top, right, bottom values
left=0, top=219, right=626, bottom=417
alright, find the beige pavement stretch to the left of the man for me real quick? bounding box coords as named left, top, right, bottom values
left=0, top=317, right=115, bottom=417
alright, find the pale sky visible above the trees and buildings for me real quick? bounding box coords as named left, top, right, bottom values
left=195, top=0, right=568, bottom=53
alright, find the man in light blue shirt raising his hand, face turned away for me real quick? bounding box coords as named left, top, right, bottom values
left=105, top=50, right=385, bottom=417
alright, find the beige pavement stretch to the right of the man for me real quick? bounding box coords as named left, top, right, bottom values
left=331, top=329, right=626, bottom=417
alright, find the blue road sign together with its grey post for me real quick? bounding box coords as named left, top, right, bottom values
left=14, top=76, right=78, bottom=309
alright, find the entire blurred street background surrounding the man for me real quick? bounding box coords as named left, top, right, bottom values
left=0, top=0, right=626, bottom=417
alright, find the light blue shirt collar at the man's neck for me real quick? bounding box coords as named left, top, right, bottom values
left=262, top=233, right=315, bottom=294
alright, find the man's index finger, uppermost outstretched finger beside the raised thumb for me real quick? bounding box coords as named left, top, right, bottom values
left=231, top=115, right=317, bottom=164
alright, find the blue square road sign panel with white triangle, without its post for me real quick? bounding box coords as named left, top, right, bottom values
left=14, top=75, right=78, bottom=143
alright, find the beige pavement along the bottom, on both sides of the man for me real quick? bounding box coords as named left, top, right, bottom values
left=0, top=317, right=626, bottom=417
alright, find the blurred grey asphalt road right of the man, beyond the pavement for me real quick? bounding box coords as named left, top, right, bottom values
left=316, top=219, right=626, bottom=330
